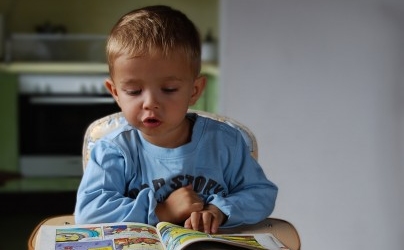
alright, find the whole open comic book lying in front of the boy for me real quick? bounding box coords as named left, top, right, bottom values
left=35, top=222, right=288, bottom=250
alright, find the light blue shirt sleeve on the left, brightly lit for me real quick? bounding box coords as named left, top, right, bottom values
left=74, top=140, right=158, bottom=225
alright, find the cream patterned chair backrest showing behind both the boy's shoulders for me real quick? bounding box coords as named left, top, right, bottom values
left=83, top=109, right=258, bottom=171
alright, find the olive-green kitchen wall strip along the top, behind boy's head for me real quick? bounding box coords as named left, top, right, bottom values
left=0, top=0, right=219, bottom=36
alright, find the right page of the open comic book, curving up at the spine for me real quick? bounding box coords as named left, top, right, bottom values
left=157, top=222, right=287, bottom=250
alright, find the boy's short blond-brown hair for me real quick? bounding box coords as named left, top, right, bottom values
left=106, top=5, right=201, bottom=76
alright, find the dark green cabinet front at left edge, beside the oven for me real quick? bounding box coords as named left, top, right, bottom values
left=0, top=72, right=18, bottom=173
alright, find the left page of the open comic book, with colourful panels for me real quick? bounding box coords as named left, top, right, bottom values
left=35, top=222, right=165, bottom=250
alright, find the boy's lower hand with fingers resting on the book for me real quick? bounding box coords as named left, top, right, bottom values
left=184, top=205, right=226, bottom=234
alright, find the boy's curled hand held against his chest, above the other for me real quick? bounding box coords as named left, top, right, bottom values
left=155, top=185, right=204, bottom=223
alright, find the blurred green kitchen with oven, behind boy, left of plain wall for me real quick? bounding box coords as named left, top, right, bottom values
left=0, top=0, right=218, bottom=249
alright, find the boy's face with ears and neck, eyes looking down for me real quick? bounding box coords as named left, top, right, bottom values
left=106, top=51, right=206, bottom=148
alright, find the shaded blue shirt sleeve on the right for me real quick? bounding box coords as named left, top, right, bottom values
left=208, top=134, right=278, bottom=227
